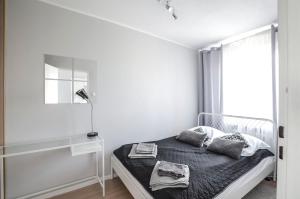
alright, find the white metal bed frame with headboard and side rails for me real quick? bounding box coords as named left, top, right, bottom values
left=111, top=113, right=277, bottom=199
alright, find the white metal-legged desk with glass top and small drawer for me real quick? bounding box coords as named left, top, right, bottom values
left=0, top=134, right=105, bottom=199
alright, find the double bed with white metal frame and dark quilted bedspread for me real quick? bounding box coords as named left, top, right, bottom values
left=111, top=113, right=277, bottom=199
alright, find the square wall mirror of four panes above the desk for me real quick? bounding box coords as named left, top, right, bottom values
left=44, top=55, right=97, bottom=104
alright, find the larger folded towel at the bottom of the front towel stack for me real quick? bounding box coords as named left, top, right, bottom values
left=150, top=161, right=190, bottom=191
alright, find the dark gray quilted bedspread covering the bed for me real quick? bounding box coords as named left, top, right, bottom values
left=114, top=137, right=273, bottom=199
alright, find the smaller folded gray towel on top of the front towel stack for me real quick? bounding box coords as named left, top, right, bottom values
left=158, top=161, right=186, bottom=179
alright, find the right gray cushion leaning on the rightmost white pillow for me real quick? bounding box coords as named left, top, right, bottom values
left=207, top=138, right=245, bottom=160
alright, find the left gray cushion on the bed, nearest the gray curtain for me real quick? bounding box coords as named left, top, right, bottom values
left=176, top=130, right=206, bottom=147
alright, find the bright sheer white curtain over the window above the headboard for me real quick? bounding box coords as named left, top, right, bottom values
left=222, top=30, right=274, bottom=119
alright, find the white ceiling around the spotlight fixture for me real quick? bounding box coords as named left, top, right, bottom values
left=42, top=0, right=277, bottom=49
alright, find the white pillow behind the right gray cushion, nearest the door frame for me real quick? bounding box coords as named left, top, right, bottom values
left=241, top=133, right=271, bottom=156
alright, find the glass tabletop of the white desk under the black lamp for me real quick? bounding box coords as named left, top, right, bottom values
left=0, top=134, right=103, bottom=158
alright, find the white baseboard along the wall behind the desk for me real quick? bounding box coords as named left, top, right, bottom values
left=17, top=175, right=112, bottom=199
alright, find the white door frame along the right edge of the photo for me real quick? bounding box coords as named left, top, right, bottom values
left=277, top=0, right=300, bottom=199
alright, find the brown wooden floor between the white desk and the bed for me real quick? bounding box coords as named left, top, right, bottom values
left=52, top=178, right=133, bottom=199
